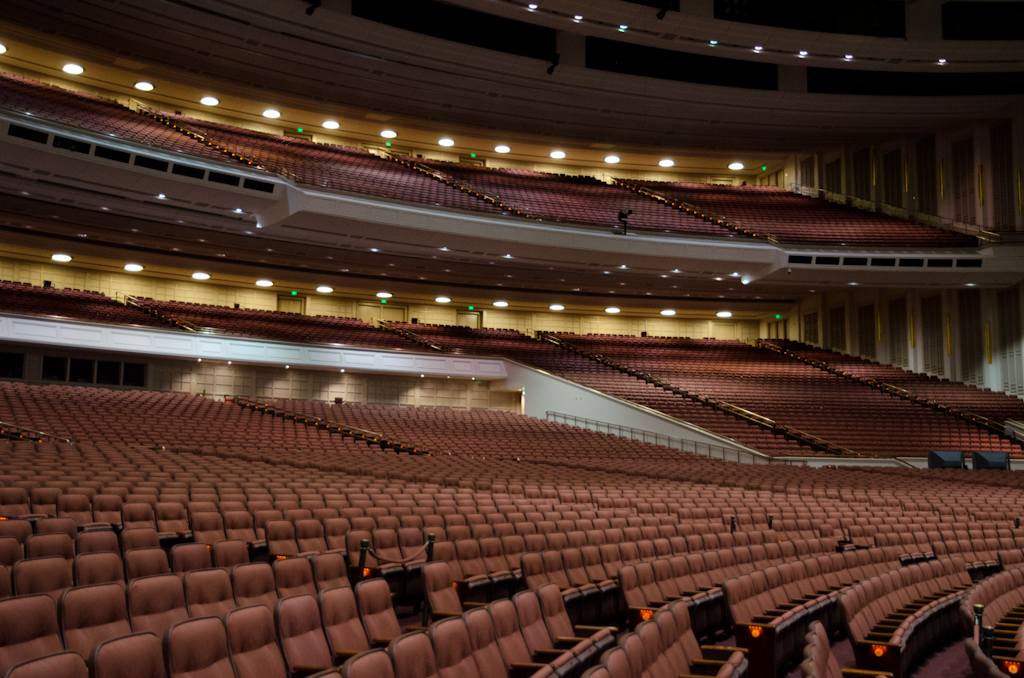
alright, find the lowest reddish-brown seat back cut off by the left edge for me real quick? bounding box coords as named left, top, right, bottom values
left=0, top=595, right=65, bottom=675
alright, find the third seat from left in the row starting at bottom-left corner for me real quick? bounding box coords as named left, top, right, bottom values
left=164, top=617, right=234, bottom=678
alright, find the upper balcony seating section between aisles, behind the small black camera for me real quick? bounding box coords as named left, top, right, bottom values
left=410, top=159, right=732, bottom=238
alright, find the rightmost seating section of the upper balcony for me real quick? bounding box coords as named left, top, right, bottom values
left=628, top=180, right=975, bottom=247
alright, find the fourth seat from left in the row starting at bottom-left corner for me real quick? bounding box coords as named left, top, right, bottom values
left=224, top=605, right=287, bottom=678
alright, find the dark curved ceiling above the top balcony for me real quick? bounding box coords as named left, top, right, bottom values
left=0, top=0, right=1024, bottom=165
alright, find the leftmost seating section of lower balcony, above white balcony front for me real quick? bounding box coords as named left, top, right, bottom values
left=0, top=281, right=167, bottom=328
